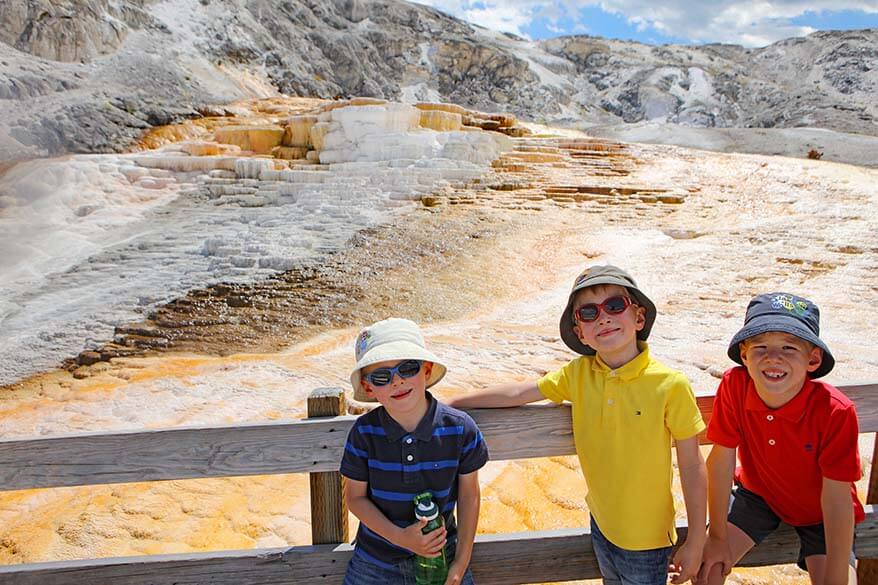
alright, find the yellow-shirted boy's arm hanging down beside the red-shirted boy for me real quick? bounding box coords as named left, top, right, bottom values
left=671, top=435, right=707, bottom=583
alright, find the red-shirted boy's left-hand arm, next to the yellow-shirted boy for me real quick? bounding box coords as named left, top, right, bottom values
left=698, top=444, right=735, bottom=583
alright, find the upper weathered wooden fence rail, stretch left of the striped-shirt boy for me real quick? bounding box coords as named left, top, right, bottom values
left=0, top=416, right=354, bottom=490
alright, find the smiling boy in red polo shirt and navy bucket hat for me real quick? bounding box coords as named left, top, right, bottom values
left=698, top=293, right=864, bottom=585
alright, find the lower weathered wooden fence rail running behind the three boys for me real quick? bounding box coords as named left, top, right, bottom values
left=0, top=506, right=878, bottom=585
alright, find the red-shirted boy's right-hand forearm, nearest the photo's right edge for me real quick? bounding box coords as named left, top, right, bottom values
left=820, top=477, right=854, bottom=585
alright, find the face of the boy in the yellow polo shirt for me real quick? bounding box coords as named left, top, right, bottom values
left=573, top=284, right=646, bottom=368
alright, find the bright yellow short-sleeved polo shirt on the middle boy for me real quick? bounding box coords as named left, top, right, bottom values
left=538, top=342, right=704, bottom=550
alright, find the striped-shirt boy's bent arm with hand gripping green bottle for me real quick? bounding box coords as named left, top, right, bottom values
left=344, top=477, right=445, bottom=557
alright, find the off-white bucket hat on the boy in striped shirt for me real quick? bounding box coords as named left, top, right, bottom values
left=351, top=317, right=447, bottom=401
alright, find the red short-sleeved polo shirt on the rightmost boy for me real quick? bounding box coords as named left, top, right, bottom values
left=707, top=367, right=865, bottom=526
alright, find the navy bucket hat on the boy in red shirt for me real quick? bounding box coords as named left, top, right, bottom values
left=728, top=293, right=835, bottom=378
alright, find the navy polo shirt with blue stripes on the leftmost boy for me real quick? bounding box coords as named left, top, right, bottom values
left=340, top=392, right=488, bottom=567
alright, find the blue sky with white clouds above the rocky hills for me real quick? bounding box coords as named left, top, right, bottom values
left=416, top=0, right=878, bottom=47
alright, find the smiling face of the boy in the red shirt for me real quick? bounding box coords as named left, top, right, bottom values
left=741, top=331, right=823, bottom=408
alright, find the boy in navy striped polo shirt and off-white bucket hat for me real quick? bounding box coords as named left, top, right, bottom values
left=340, top=318, right=488, bottom=585
